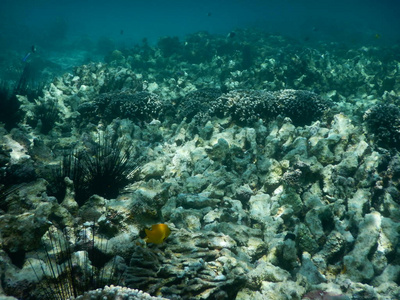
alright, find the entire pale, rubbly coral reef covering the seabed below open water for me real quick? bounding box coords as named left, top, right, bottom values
left=0, top=30, right=400, bottom=300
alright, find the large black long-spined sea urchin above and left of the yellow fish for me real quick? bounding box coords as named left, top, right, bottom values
left=50, top=134, right=136, bottom=205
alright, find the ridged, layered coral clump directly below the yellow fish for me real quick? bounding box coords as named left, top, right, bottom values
left=125, top=230, right=248, bottom=299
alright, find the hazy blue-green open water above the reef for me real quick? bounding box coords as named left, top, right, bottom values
left=0, top=0, right=400, bottom=76
